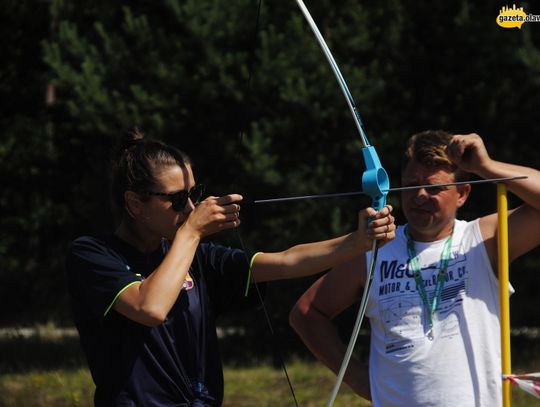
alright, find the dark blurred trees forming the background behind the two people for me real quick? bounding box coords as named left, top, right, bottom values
left=0, top=0, right=540, bottom=405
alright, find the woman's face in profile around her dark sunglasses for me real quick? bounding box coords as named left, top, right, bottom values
left=143, top=165, right=195, bottom=240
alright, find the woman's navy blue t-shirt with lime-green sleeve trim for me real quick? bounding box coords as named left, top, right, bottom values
left=67, top=236, right=256, bottom=407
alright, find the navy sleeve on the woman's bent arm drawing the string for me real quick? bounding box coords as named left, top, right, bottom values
left=66, top=237, right=142, bottom=319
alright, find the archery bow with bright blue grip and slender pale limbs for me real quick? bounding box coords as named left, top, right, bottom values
left=296, top=0, right=390, bottom=407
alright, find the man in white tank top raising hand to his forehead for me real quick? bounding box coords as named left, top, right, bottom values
left=290, top=131, right=540, bottom=407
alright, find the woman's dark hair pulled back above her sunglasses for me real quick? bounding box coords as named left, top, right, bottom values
left=111, top=127, right=191, bottom=214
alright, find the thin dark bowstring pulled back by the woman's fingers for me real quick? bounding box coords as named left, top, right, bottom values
left=235, top=0, right=298, bottom=407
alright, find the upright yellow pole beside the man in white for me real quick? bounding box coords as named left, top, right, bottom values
left=497, top=183, right=512, bottom=407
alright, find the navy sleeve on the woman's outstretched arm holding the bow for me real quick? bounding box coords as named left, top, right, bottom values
left=197, top=243, right=266, bottom=314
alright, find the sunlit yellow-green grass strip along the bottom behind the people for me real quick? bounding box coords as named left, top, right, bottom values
left=0, top=361, right=540, bottom=407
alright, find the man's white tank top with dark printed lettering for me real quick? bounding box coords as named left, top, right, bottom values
left=366, top=219, right=512, bottom=407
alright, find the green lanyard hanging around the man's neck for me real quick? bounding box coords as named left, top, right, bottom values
left=405, top=226, right=454, bottom=339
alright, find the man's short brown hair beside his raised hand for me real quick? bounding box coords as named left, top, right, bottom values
left=401, top=130, right=469, bottom=182
